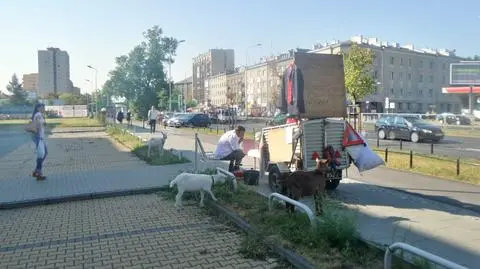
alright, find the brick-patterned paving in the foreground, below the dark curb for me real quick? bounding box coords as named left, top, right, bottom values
left=0, top=194, right=281, bottom=269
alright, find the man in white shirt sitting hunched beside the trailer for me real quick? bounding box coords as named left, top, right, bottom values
left=215, top=126, right=245, bottom=172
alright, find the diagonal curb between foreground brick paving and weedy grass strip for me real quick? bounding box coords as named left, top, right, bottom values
left=206, top=200, right=316, bottom=269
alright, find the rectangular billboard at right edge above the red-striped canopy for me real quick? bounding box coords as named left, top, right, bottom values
left=450, top=62, right=480, bottom=85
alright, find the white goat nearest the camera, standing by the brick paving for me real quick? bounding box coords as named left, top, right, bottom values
left=170, top=173, right=227, bottom=207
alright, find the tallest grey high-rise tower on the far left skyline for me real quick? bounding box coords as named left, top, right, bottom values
left=38, top=48, right=73, bottom=97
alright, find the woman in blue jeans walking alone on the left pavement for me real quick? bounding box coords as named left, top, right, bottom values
left=32, top=103, right=48, bottom=180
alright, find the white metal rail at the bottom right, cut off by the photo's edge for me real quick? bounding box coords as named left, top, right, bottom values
left=383, top=242, right=468, bottom=269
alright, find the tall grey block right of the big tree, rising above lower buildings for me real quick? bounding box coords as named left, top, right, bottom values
left=192, top=49, right=235, bottom=105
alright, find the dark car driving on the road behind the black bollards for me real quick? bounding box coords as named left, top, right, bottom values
left=375, top=115, right=445, bottom=143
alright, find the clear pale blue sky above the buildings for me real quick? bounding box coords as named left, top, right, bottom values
left=0, top=0, right=480, bottom=92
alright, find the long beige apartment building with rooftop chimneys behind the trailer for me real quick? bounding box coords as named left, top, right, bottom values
left=311, top=36, right=462, bottom=113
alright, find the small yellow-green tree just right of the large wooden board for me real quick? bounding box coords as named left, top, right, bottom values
left=343, top=44, right=376, bottom=103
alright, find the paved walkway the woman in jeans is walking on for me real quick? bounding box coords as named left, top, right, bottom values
left=0, top=129, right=193, bottom=208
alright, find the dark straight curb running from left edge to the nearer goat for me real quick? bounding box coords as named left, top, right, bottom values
left=0, top=186, right=168, bottom=210
